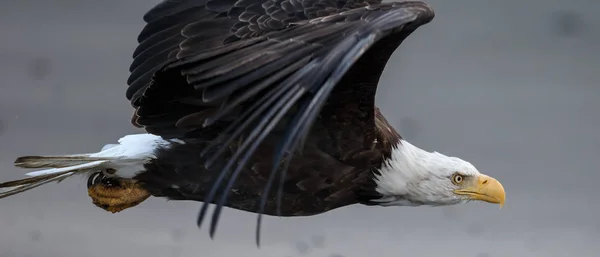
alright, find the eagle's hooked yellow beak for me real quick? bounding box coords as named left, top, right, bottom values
left=454, top=174, right=506, bottom=208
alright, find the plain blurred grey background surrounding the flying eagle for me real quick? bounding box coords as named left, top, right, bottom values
left=0, top=0, right=600, bottom=257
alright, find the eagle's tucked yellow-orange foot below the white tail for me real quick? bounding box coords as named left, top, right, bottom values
left=88, top=173, right=150, bottom=213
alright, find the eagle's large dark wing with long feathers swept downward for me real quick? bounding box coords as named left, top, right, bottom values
left=127, top=0, right=434, bottom=242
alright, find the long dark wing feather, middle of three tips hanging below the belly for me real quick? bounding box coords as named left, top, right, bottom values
left=210, top=86, right=306, bottom=238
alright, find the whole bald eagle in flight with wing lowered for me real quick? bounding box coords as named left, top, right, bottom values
left=0, top=0, right=505, bottom=244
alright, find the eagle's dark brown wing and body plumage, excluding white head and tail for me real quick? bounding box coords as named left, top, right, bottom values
left=127, top=0, right=433, bottom=239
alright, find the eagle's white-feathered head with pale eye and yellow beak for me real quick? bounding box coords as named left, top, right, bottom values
left=374, top=140, right=505, bottom=206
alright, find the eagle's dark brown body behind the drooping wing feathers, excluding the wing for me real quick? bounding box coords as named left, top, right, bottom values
left=136, top=107, right=399, bottom=216
